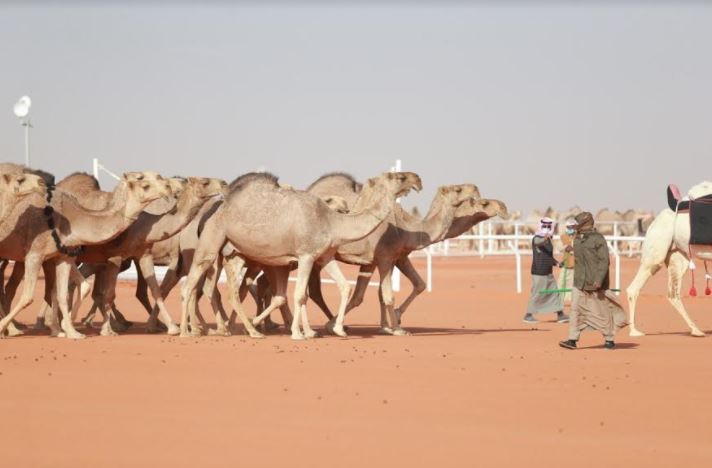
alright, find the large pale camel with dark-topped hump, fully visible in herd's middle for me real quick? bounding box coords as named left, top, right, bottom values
left=181, top=172, right=422, bottom=340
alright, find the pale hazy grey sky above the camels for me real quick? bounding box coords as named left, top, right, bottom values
left=0, top=0, right=712, bottom=211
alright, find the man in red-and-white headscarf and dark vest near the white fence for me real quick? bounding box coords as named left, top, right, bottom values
left=524, top=217, right=569, bottom=325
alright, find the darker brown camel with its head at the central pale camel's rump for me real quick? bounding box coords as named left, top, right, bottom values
left=71, top=177, right=226, bottom=336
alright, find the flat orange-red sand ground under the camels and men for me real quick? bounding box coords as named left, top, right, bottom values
left=0, top=258, right=712, bottom=467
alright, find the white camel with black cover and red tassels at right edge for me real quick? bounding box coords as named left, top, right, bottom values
left=626, top=182, right=712, bottom=336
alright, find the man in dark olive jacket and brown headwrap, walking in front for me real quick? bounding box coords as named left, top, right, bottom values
left=559, top=211, right=627, bottom=349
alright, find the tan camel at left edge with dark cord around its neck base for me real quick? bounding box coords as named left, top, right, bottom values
left=0, top=170, right=169, bottom=338
